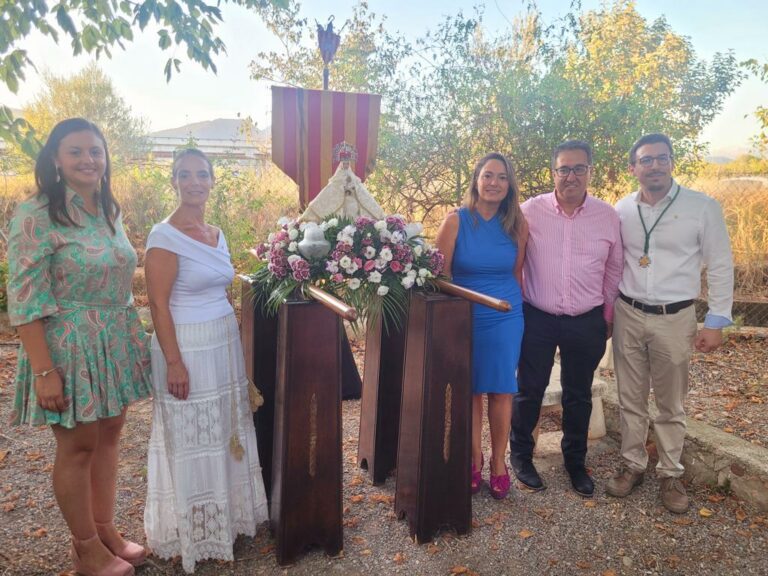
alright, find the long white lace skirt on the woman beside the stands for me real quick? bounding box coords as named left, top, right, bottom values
left=144, top=314, right=268, bottom=572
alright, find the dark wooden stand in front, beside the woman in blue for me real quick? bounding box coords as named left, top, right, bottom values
left=395, top=292, right=472, bottom=542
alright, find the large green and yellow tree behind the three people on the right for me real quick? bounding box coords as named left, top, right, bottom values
left=252, top=0, right=743, bottom=225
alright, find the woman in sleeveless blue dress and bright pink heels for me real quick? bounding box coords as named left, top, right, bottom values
left=437, top=152, right=528, bottom=499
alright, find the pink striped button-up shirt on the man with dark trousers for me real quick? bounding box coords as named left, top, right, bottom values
left=521, top=192, right=624, bottom=322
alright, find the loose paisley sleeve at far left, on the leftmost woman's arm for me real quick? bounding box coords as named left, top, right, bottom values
left=8, top=200, right=58, bottom=326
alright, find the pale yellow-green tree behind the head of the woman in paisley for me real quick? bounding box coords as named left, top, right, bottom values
left=23, top=64, right=147, bottom=165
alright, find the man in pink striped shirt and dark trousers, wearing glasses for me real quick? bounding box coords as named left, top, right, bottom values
left=510, top=140, right=623, bottom=497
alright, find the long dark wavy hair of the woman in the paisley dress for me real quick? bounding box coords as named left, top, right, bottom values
left=35, top=118, right=120, bottom=234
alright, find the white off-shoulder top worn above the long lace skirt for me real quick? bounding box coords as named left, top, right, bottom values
left=147, top=222, right=235, bottom=324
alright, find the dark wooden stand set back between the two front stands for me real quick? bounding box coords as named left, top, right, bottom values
left=357, top=320, right=405, bottom=485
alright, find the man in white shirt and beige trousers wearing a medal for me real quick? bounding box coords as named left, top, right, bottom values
left=606, top=134, right=733, bottom=514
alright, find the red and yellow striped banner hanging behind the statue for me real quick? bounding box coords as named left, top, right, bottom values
left=272, top=86, right=381, bottom=210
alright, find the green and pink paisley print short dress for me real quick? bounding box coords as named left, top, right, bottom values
left=8, top=190, right=152, bottom=428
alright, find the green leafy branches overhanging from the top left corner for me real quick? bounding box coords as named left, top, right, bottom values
left=0, top=0, right=288, bottom=155
